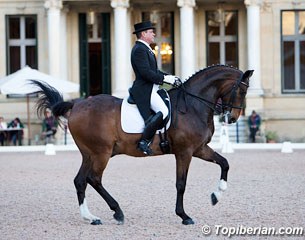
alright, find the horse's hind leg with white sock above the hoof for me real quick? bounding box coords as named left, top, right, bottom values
left=74, top=155, right=102, bottom=225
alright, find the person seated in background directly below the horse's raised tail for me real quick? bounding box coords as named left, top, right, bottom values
left=42, top=109, right=58, bottom=143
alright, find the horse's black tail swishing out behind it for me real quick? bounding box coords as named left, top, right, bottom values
left=31, top=80, right=74, bottom=119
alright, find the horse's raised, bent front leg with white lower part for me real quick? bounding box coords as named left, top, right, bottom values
left=193, top=145, right=229, bottom=205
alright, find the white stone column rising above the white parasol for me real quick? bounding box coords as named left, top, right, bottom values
left=44, top=0, right=62, bottom=77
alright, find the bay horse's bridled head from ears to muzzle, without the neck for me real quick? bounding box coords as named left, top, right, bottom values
left=222, top=70, right=254, bottom=123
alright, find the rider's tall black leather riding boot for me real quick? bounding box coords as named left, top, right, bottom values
left=138, top=112, right=163, bottom=155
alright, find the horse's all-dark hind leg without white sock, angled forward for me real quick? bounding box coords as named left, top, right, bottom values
left=87, top=155, right=124, bottom=224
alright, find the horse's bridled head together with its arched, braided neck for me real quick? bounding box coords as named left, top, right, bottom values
left=179, top=65, right=254, bottom=123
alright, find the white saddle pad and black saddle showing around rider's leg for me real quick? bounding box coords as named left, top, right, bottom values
left=121, top=89, right=171, bottom=153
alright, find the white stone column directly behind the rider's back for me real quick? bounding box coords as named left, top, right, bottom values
left=111, top=0, right=131, bottom=97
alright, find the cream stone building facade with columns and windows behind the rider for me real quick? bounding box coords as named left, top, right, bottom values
left=0, top=0, right=305, bottom=142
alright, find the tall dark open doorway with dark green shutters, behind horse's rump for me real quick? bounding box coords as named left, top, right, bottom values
left=79, top=13, right=111, bottom=97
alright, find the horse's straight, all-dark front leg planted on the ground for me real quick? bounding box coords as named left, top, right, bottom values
left=175, top=154, right=194, bottom=225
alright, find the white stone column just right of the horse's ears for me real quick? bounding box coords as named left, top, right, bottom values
left=245, top=0, right=263, bottom=96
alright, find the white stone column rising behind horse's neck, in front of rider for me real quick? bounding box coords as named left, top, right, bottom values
left=177, top=0, right=196, bottom=80
